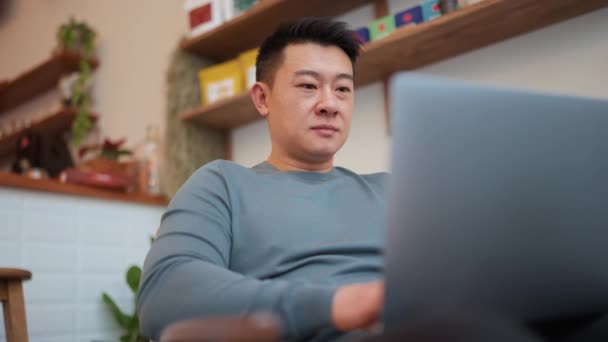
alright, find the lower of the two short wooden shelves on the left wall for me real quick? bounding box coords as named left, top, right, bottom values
left=0, top=108, right=97, bottom=157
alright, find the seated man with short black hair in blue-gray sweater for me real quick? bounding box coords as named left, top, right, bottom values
left=137, top=19, right=386, bottom=340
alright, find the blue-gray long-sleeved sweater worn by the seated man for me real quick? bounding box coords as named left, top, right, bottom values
left=137, top=160, right=386, bottom=339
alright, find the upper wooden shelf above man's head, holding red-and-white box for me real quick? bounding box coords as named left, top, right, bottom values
left=180, top=0, right=373, bottom=61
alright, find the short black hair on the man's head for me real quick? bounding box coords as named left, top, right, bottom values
left=255, top=18, right=361, bottom=85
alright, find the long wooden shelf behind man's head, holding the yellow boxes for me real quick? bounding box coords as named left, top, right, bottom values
left=180, top=0, right=608, bottom=129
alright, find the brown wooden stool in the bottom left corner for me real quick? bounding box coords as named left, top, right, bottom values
left=0, top=268, right=32, bottom=342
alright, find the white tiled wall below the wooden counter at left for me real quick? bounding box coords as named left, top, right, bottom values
left=0, top=188, right=163, bottom=342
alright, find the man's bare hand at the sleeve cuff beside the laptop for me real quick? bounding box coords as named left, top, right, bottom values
left=331, top=281, right=384, bottom=331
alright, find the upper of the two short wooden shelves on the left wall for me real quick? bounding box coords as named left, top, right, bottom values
left=0, top=52, right=99, bottom=115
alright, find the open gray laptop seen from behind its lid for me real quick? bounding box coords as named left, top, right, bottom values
left=384, top=73, right=608, bottom=328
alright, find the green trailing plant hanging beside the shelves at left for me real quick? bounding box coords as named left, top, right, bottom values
left=57, top=18, right=95, bottom=145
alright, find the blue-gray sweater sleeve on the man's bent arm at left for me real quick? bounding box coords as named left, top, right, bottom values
left=137, top=162, right=335, bottom=339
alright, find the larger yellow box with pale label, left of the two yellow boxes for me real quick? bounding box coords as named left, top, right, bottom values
left=198, top=59, right=244, bottom=105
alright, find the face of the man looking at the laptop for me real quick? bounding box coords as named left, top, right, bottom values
left=267, top=43, right=354, bottom=162
